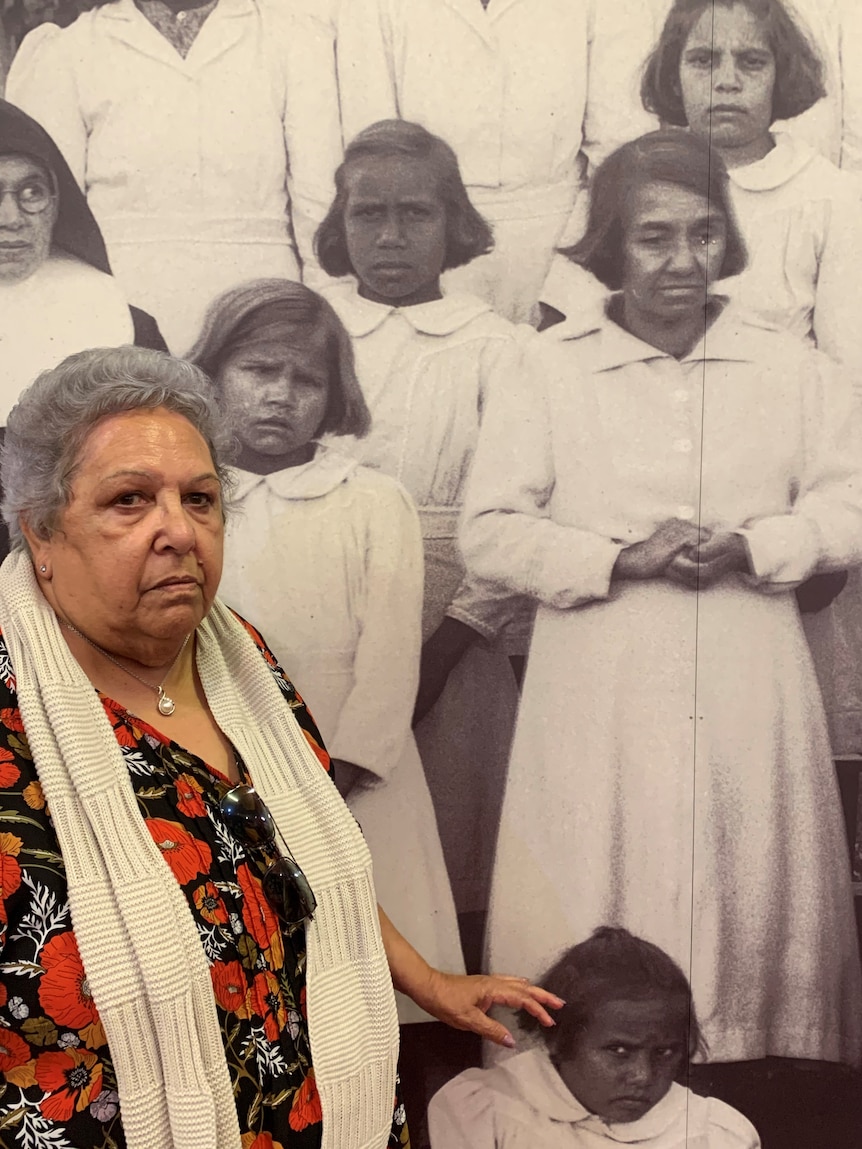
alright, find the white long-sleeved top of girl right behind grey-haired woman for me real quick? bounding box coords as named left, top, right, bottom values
left=218, top=447, right=422, bottom=778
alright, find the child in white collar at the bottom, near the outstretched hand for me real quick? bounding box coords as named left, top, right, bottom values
left=429, top=926, right=760, bottom=1149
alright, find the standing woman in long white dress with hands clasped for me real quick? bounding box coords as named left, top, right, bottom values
left=463, top=131, right=862, bottom=1075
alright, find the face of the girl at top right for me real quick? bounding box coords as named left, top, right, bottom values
left=679, top=3, right=775, bottom=165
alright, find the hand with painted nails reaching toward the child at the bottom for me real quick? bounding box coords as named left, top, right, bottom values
left=418, top=970, right=565, bottom=1049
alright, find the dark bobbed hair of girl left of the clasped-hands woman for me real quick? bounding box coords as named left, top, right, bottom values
left=314, top=119, right=494, bottom=276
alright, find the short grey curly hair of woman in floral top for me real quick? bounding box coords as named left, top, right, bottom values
left=0, top=347, right=232, bottom=549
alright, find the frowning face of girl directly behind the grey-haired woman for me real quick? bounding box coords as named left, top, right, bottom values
left=217, top=333, right=329, bottom=466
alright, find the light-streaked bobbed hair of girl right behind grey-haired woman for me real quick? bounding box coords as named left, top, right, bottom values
left=187, top=279, right=371, bottom=438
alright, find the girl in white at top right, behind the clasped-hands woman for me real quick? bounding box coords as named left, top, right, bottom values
left=644, top=0, right=862, bottom=756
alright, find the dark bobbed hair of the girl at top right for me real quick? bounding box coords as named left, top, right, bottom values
left=640, top=0, right=826, bottom=128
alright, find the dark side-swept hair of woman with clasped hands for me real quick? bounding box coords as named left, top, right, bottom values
left=561, top=129, right=746, bottom=291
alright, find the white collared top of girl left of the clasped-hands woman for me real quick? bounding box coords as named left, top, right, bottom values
left=326, top=285, right=533, bottom=638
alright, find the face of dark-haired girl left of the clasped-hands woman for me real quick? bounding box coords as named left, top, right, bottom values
left=345, top=155, right=446, bottom=307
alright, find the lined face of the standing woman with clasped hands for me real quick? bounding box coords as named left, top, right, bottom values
left=623, top=183, right=726, bottom=324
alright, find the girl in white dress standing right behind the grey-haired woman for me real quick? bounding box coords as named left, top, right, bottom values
left=193, top=279, right=463, bottom=1021
